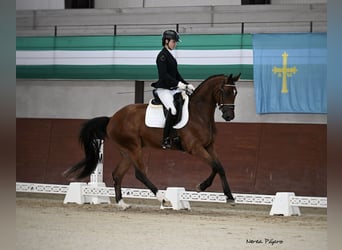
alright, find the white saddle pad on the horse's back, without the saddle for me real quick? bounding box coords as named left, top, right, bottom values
left=145, top=95, right=189, bottom=129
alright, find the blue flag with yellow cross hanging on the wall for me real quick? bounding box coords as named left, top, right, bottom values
left=253, top=33, right=327, bottom=114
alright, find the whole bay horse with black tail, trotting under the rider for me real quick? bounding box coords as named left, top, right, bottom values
left=63, top=73, right=241, bottom=210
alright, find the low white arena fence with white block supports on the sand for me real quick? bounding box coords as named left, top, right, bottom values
left=16, top=182, right=327, bottom=216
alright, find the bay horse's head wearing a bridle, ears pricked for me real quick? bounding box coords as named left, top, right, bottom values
left=216, top=73, right=241, bottom=121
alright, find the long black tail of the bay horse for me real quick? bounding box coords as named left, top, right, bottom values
left=63, top=116, right=109, bottom=179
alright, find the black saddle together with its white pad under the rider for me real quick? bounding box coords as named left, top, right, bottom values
left=145, top=90, right=189, bottom=129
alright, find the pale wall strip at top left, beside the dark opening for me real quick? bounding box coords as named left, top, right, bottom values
left=16, top=0, right=65, bottom=10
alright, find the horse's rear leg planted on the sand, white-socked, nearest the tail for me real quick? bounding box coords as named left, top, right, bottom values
left=112, top=156, right=131, bottom=210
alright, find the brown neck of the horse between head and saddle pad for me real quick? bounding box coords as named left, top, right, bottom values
left=191, top=80, right=216, bottom=127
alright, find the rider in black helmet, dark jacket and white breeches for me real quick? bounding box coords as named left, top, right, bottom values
left=151, top=30, right=195, bottom=149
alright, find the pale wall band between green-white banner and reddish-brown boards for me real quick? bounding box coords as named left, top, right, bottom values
left=16, top=80, right=327, bottom=124
